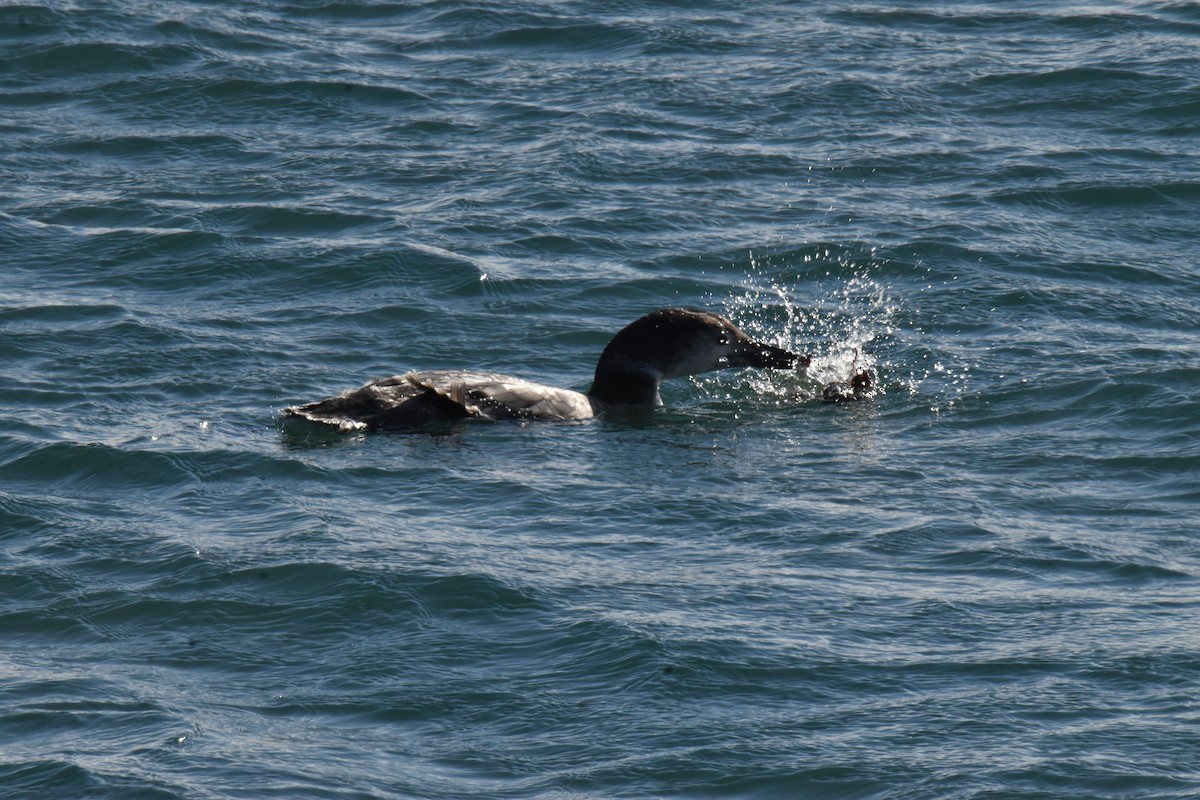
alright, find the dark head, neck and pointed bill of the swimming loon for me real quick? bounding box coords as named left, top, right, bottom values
left=588, top=308, right=810, bottom=405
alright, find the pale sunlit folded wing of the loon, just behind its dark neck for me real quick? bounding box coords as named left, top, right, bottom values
left=403, top=369, right=595, bottom=420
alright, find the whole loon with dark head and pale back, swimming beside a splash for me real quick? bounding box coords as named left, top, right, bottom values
left=283, top=308, right=811, bottom=433
